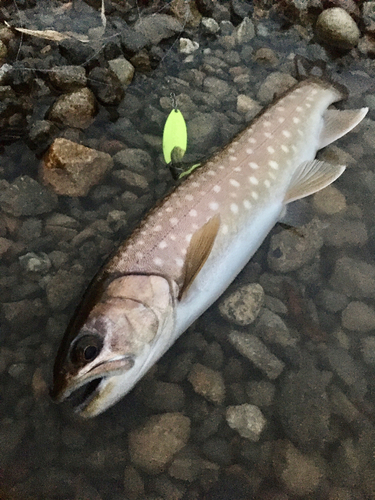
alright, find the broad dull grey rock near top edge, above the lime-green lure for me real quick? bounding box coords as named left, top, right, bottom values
left=134, top=14, right=183, bottom=45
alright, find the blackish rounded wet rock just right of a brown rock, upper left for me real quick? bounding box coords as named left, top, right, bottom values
left=88, top=63, right=124, bottom=106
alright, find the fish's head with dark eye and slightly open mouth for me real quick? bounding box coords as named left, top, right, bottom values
left=51, top=275, right=176, bottom=417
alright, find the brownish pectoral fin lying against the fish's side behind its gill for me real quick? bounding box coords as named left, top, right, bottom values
left=178, top=215, right=220, bottom=300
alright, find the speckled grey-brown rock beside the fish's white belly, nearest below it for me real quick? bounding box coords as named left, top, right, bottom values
left=219, top=283, right=264, bottom=326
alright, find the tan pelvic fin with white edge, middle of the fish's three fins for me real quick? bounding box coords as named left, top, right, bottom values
left=284, top=160, right=345, bottom=204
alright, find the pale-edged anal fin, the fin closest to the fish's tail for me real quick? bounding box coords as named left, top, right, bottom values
left=318, top=108, right=368, bottom=149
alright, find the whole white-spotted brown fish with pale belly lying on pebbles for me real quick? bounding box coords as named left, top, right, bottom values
left=51, top=77, right=368, bottom=418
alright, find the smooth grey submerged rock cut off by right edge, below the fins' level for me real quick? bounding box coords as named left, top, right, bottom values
left=330, top=257, right=375, bottom=299
